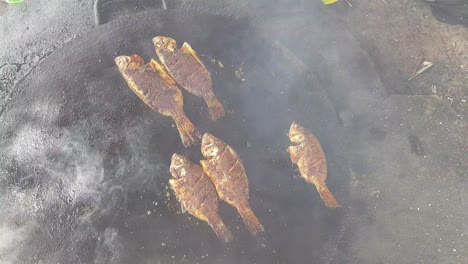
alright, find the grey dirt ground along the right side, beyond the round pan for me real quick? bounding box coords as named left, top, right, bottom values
left=330, top=0, right=468, bottom=263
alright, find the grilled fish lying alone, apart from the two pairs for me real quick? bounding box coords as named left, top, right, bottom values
left=288, top=122, right=340, bottom=208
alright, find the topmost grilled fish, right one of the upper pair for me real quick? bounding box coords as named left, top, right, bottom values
left=153, top=36, right=225, bottom=121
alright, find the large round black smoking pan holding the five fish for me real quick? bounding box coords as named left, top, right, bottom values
left=0, top=11, right=349, bottom=263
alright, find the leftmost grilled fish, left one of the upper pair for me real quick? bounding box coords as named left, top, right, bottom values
left=115, top=55, right=201, bottom=147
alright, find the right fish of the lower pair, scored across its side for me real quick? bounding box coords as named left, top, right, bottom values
left=200, top=133, right=263, bottom=235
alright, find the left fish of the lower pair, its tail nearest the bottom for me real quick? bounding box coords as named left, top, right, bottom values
left=169, top=153, right=232, bottom=242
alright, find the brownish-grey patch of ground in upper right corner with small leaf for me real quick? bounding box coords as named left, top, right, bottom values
left=332, top=0, right=468, bottom=114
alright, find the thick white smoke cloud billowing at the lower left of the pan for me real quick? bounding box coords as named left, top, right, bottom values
left=0, top=112, right=167, bottom=263
